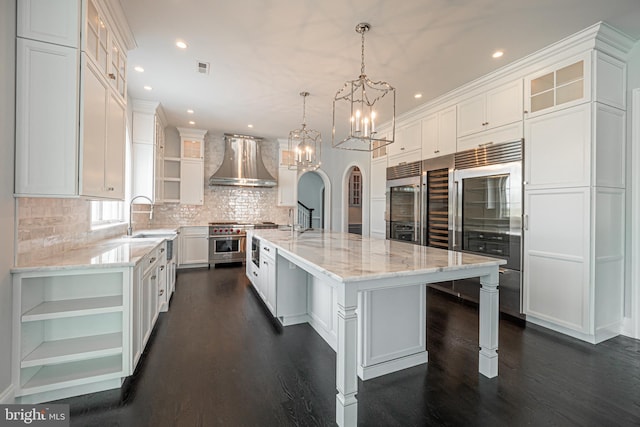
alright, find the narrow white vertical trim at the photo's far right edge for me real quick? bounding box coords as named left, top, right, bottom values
left=625, top=88, right=640, bottom=338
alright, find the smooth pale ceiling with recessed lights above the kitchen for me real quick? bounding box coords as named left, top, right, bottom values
left=116, top=0, right=640, bottom=143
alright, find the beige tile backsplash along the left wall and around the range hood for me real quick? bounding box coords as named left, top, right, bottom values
left=17, top=132, right=289, bottom=262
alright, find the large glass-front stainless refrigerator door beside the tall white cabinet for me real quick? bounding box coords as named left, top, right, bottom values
left=453, top=161, right=522, bottom=271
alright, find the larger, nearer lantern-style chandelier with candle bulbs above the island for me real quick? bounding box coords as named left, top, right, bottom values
left=332, top=22, right=396, bottom=151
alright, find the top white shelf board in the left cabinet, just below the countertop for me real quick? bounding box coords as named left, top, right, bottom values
left=22, top=295, right=122, bottom=322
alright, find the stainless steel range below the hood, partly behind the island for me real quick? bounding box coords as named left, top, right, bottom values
left=209, top=221, right=277, bottom=267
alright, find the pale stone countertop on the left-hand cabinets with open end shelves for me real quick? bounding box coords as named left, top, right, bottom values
left=11, top=229, right=176, bottom=273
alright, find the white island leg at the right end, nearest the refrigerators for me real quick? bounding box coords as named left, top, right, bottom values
left=478, top=266, right=500, bottom=378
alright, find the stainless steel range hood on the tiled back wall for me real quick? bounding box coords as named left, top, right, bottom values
left=209, top=134, right=277, bottom=187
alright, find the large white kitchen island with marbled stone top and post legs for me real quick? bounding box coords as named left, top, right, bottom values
left=247, top=230, right=505, bottom=426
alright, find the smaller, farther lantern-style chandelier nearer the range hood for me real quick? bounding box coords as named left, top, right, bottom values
left=287, top=92, right=322, bottom=171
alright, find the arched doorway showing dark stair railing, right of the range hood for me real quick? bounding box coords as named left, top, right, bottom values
left=298, top=169, right=331, bottom=230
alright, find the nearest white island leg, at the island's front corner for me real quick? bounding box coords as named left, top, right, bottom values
left=336, top=283, right=358, bottom=427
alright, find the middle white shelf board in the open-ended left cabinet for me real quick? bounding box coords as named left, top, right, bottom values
left=20, top=332, right=122, bottom=368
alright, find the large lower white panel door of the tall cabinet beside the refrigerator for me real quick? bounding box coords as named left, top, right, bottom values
left=522, top=188, right=590, bottom=332
